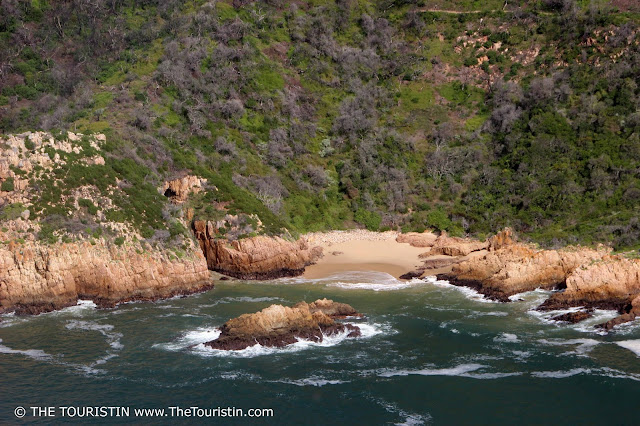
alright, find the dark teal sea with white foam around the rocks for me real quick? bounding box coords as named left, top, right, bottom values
left=0, top=273, right=640, bottom=425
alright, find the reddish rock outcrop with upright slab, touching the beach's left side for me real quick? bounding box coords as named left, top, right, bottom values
left=193, top=221, right=322, bottom=280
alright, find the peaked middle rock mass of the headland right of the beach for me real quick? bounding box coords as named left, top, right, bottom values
left=438, top=230, right=610, bottom=302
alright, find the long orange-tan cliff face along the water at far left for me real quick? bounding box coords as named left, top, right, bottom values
left=0, top=242, right=213, bottom=314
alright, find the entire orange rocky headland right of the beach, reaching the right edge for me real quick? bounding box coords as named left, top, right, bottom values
left=410, top=229, right=640, bottom=330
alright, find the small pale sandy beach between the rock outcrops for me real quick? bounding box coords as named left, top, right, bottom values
left=304, top=229, right=439, bottom=279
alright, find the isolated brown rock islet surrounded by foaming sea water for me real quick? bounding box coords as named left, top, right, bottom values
left=205, top=299, right=360, bottom=350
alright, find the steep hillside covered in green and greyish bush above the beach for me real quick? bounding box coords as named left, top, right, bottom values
left=0, top=0, right=640, bottom=249
